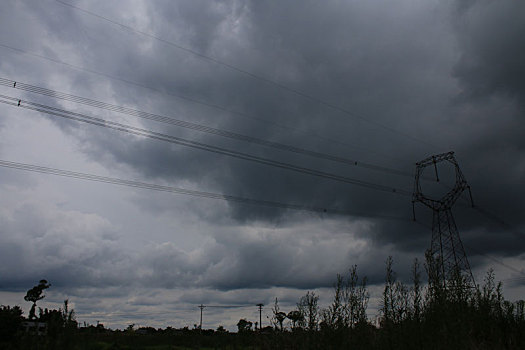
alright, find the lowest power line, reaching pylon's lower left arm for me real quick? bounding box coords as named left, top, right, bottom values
left=0, top=159, right=410, bottom=221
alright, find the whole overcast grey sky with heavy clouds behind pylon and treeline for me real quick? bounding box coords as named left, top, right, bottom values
left=0, top=0, right=525, bottom=329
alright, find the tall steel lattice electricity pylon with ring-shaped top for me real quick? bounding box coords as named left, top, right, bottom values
left=412, top=152, right=475, bottom=287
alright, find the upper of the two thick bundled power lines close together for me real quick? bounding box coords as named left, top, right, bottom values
left=0, top=78, right=413, bottom=177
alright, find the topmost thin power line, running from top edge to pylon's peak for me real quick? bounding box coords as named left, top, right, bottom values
left=55, top=0, right=436, bottom=148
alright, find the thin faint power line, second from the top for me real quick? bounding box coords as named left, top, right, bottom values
left=0, top=43, right=402, bottom=161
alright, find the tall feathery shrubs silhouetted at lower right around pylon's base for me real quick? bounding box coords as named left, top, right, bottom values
left=266, top=256, right=525, bottom=349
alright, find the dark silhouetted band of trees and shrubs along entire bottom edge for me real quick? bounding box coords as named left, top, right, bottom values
left=0, top=257, right=525, bottom=349
